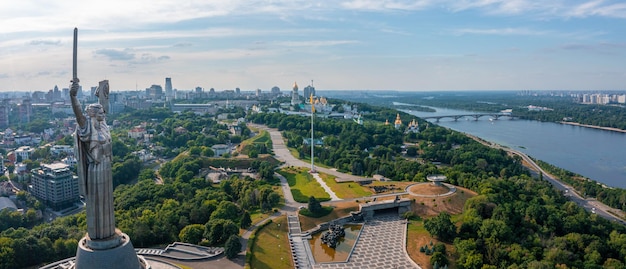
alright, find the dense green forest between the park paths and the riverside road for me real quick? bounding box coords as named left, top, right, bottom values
left=249, top=105, right=626, bottom=269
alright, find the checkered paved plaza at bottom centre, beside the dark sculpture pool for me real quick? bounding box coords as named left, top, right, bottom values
left=313, top=214, right=420, bottom=269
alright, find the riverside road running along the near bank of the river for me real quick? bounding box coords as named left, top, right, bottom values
left=468, top=135, right=626, bottom=225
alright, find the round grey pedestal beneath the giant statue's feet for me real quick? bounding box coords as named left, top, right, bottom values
left=74, top=230, right=150, bottom=269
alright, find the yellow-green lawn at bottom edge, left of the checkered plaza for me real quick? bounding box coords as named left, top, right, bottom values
left=249, top=216, right=294, bottom=269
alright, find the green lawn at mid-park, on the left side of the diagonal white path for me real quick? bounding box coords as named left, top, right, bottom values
left=278, top=168, right=330, bottom=203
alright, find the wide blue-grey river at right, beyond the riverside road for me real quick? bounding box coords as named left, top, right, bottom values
left=398, top=103, right=626, bottom=188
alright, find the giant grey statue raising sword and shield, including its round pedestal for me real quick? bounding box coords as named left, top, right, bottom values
left=70, top=28, right=149, bottom=269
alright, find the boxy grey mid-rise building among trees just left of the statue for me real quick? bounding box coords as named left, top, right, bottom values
left=29, top=162, right=80, bottom=210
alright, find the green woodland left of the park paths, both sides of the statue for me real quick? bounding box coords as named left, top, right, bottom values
left=0, top=105, right=272, bottom=269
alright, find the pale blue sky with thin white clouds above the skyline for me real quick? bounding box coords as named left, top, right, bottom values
left=0, top=0, right=626, bottom=91
